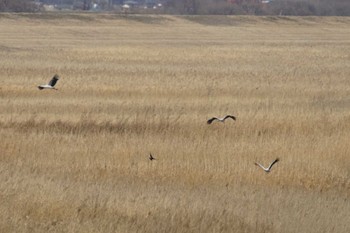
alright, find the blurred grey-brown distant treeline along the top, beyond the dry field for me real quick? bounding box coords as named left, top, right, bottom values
left=0, top=0, right=350, bottom=16
